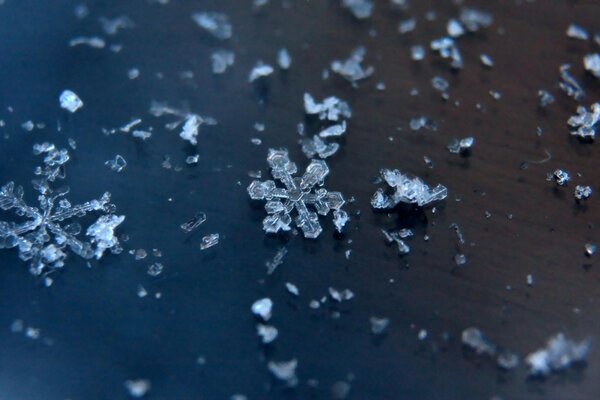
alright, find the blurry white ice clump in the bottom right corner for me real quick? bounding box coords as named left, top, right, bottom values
left=525, top=333, right=590, bottom=376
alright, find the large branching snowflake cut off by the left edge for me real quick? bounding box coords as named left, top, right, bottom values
left=0, top=143, right=125, bottom=275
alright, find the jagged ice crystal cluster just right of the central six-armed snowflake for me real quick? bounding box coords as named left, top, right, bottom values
left=371, top=169, right=448, bottom=209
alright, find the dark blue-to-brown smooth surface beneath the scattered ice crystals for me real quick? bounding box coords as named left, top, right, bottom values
left=0, top=0, right=600, bottom=400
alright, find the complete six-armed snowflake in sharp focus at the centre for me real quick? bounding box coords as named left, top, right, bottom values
left=248, top=149, right=345, bottom=239
